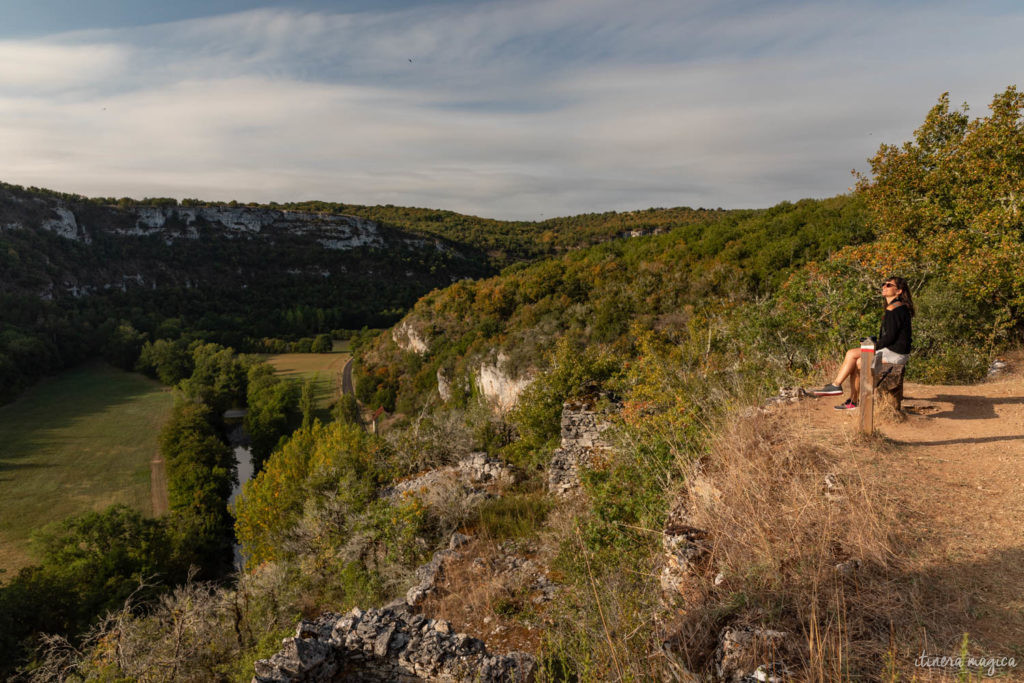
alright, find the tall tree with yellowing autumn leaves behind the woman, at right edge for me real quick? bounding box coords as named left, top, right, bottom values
left=858, top=86, right=1024, bottom=317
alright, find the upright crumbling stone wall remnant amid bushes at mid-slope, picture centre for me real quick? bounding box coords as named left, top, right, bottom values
left=548, top=396, right=615, bottom=496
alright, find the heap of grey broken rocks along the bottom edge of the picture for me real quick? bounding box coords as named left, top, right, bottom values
left=252, top=602, right=537, bottom=683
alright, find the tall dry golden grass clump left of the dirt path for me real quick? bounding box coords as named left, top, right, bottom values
left=670, top=414, right=901, bottom=681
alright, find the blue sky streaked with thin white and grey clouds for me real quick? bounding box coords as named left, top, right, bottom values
left=0, top=0, right=1024, bottom=218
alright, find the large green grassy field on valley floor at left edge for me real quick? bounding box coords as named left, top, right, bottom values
left=0, top=362, right=173, bottom=582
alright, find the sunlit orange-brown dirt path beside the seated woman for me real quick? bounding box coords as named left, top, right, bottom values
left=802, top=355, right=1024, bottom=663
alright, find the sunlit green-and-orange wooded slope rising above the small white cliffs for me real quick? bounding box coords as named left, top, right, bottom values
left=359, top=196, right=873, bottom=413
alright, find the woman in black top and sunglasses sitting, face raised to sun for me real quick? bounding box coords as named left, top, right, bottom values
left=812, top=278, right=913, bottom=411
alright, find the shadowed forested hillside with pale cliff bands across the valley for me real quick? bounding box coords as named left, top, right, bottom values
left=0, top=185, right=494, bottom=401
